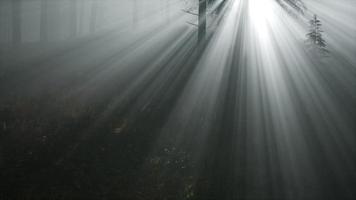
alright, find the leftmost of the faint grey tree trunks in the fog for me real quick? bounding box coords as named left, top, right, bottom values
left=11, top=0, right=21, bottom=44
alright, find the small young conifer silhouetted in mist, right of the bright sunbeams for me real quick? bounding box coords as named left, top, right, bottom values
left=306, top=15, right=329, bottom=54
